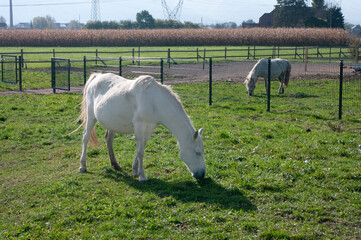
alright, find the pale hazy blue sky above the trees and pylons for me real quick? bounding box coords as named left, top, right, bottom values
left=0, top=0, right=361, bottom=25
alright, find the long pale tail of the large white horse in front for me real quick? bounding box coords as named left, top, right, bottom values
left=70, top=73, right=99, bottom=147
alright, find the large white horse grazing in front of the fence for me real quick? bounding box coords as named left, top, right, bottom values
left=78, top=73, right=206, bottom=182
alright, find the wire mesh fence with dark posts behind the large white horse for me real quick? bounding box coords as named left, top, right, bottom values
left=0, top=51, right=361, bottom=122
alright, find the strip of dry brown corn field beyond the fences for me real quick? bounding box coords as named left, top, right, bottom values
left=0, top=28, right=350, bottom=47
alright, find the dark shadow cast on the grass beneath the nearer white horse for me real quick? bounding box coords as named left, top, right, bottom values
left=103, top=169, right=257, bottom=212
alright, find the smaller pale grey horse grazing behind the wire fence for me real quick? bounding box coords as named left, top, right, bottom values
left=245, top=58, right=291, bottom=96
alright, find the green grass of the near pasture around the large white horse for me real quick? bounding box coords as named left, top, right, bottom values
left=0, top=82, right=361, bottom=239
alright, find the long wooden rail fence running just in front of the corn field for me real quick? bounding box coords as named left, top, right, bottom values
left=0, top=46, right=361, bottom=67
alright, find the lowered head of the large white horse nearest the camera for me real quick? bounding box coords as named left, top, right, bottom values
left=179, top=128, right=206, bottom=179
